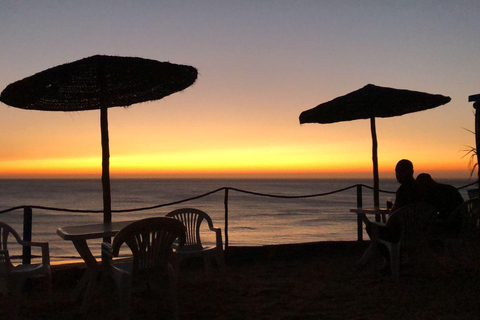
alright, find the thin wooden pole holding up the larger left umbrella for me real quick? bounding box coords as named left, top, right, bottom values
left=100, top=107, right=112, bottom=242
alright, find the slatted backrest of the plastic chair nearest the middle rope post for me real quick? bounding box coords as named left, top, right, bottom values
left=167, top=208, right=213, bottom=249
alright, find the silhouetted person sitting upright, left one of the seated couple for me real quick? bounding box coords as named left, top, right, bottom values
left=392, top=159, right=417, bottom=212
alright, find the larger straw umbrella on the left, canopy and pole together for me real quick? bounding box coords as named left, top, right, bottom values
left=0, top=55, right=197, bottom=229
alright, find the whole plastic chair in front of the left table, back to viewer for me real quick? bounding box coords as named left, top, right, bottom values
left=102, top=217, right=185, bottom=319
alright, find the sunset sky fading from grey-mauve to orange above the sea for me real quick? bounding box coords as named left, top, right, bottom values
left=0, top=0, right=480, bottom=180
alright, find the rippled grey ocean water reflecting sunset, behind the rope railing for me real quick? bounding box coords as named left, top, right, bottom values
left=0, top=179, right=472, bottom=261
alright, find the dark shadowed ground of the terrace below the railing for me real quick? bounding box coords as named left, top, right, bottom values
left=0, top=242, right=480, bottom=320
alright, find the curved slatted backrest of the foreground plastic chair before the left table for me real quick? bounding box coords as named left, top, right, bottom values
left=112, top=217, right=185, bottom=275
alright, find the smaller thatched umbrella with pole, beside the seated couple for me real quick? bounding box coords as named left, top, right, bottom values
left=300, top=84, right=450, bottom=208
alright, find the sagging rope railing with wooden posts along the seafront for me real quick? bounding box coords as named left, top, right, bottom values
left=0, top=181, right=477, bottom=264
